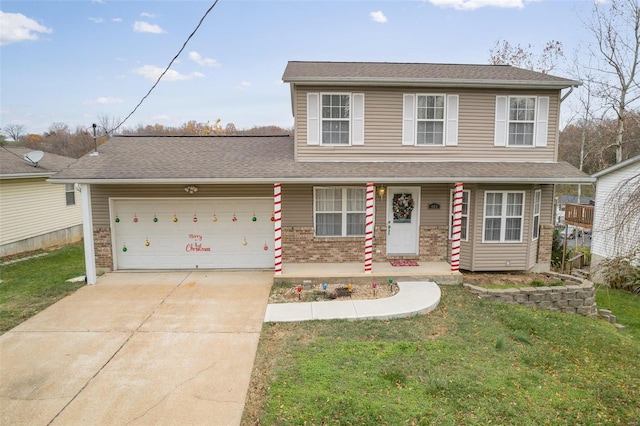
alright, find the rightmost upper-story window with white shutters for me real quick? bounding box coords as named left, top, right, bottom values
left=494, top=96, right=549, bottom=147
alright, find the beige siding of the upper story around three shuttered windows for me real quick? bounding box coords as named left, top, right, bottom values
left=294, top=86, right=559, bottom=162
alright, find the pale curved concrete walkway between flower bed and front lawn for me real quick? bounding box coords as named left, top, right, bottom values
left=264, top=281, right=441, bottom=322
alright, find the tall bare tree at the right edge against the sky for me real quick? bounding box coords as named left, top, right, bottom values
left=587, top=0, right=640, bottom=163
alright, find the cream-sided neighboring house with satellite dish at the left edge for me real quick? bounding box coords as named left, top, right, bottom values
left=0, top=147, right=82, bottom=257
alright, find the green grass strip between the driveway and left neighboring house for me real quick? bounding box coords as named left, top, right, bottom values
left=0, top=244, right=85, bottom=333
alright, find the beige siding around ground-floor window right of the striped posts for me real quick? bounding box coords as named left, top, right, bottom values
left=470, top=185, right=533, bottom=271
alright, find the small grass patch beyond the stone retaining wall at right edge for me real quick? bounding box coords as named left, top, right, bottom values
left=596, top=286, right=640, bottom=340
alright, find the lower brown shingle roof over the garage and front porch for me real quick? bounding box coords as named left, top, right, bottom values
left=52, top=136, right=594, bottom=183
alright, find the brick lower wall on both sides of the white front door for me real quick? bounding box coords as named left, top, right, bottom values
left=282, top=226, right=449, bottom=264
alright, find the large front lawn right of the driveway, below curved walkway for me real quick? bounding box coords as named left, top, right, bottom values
left=243, top=287, right=640, bottom=425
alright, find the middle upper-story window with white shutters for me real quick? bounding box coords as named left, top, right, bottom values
left=402, top=94, right=459, bottom=146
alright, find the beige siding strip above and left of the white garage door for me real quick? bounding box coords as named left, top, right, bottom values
left=89, top=185, right=273, bottom=226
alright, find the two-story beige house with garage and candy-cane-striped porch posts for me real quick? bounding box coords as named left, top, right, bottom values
left=53, top=62, right=594, bottom=282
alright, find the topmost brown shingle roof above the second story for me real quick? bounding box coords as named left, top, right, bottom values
left=282, top=61, right=580, bottom=89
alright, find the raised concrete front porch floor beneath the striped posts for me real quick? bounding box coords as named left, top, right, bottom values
left=273, top=261, right=462, bottom=285
